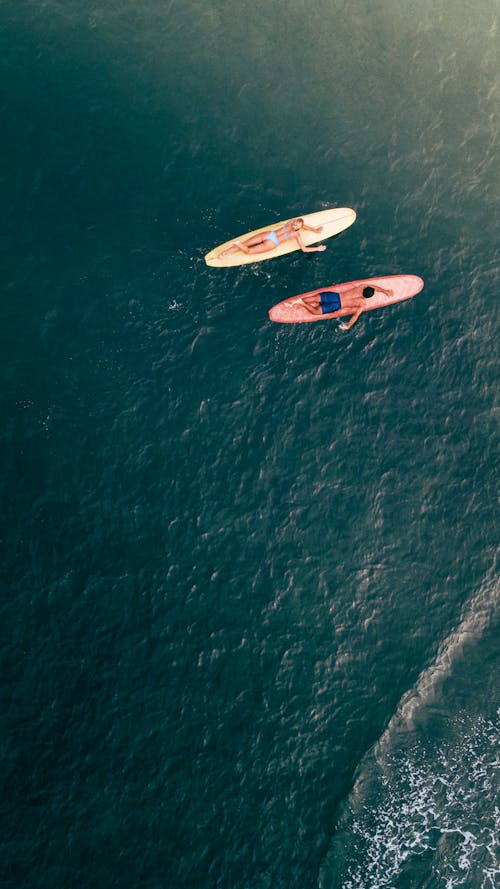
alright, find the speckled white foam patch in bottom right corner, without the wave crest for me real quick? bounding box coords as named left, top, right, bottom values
left=328, top=720, right=500, bottom=889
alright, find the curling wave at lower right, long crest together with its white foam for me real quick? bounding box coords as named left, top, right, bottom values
left=319, top=577, right=500, bottom=889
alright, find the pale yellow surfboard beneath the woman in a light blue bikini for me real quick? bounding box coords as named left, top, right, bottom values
left=205, top=207, right=356, bottom=268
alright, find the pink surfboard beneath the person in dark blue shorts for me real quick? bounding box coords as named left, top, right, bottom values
left=269, top=275, right=424, bottom=324
